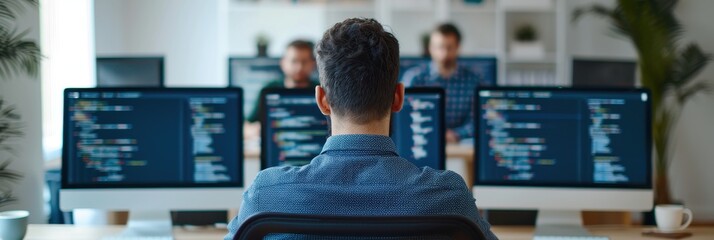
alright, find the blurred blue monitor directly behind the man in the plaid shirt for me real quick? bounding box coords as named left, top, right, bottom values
left=399, top=56, right=498, bottom=86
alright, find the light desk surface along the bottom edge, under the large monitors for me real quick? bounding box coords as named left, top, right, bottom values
left=25, top=224, right=714, bottom=240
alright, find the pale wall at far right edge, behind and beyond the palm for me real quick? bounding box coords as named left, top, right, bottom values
left=670, top=0, right=714, bottom=221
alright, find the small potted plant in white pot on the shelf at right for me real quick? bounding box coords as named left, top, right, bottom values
left=510, top=24, right=545, bottom=59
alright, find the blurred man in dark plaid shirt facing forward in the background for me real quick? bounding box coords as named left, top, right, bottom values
left=402, top=23, right=481, bottom=143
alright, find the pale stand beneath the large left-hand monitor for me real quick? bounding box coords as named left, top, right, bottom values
left=121, top=210, right=173, bottom=239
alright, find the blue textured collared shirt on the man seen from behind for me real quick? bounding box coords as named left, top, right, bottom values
left=225, top=134, right=497, bottom=240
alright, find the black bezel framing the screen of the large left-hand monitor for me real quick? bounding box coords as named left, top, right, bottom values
left=61, top=87, right=245, bottom=189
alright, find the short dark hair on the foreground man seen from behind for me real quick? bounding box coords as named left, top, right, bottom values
left=316, top=18, right=399, bottom=124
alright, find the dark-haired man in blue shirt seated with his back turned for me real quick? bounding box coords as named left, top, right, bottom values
left=225, top=18, right=496, bottom=239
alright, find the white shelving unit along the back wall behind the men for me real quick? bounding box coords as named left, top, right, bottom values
left=229, top=0, right=570, bottom=86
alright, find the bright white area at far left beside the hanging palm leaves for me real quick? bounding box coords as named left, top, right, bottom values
left=40, top=0, right=96, bottom=163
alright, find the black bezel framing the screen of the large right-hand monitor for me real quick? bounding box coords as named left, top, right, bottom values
left=473, top=87, right=653, bottom=189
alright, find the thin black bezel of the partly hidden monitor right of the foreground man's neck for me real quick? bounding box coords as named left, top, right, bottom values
left=389, top=87, right=446, bottom=170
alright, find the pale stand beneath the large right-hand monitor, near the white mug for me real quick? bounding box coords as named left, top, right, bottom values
left=533, top=210, right=593, bottom=239
